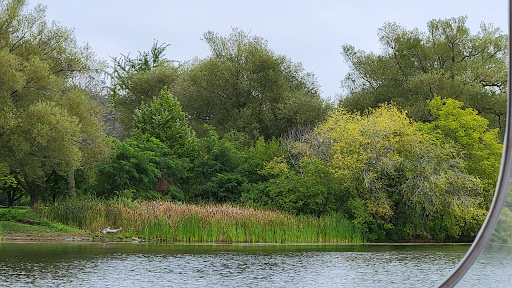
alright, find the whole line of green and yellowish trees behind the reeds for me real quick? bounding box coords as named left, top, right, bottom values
left=0, top=0, right=508, bottom=240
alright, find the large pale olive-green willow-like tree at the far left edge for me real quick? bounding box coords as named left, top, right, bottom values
left=0, top=0, right=109, bottom=204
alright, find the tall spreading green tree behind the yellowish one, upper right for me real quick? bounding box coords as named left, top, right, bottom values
left=340, top=17, right=508, bottom=132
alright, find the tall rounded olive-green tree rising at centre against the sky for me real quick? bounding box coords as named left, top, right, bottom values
left=174, top=29, right=326, bottom=141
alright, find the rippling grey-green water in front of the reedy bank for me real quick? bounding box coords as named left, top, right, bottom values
left=0, top=243, right=469, bottom=288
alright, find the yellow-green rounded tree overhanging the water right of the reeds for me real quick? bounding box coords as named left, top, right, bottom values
left=315, top=105, right=485, bottom=239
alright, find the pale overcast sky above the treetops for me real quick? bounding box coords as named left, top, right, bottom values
left=29, top=0, right=508, bottom=99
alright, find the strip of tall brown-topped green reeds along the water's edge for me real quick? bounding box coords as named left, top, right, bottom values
left=34, top=199, right=364, bottom=243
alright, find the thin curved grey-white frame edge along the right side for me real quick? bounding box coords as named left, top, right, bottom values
left=439, top=0, right=512, bottom=288
